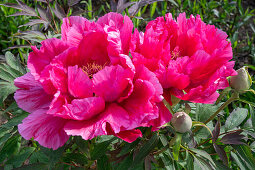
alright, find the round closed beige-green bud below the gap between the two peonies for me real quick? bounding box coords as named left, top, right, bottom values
left=171, top=112, right=192, bottom=133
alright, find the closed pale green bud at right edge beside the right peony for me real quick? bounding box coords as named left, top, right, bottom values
left=229, top=67, right=252, bottom=91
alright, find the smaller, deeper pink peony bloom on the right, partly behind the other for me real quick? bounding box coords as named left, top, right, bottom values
left=131, top=13, right=235, bottom=103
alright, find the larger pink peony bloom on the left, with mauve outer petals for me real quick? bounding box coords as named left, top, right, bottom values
left=15, top=13, right=171, bottom=149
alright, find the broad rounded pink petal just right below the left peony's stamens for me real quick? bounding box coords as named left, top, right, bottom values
left=93, top=65, right=133, bottom=102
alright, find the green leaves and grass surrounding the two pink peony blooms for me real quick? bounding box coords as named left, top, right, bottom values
left=0, top=0, right=255, bottom=170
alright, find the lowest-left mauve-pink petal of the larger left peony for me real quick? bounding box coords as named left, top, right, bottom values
left=18, top=109, right=69, bottom=150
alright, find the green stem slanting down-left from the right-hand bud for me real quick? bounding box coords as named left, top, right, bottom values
left=193, top=92, right=239, bottom=133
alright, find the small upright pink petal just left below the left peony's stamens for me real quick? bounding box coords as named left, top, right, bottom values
left=68, top=65, right=93, bottom=98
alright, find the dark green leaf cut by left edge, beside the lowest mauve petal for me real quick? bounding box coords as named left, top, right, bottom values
left=0, top=136, right=21, bottom=163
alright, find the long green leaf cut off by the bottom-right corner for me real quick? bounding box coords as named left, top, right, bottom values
left=232, top=145, right=255, bottom=169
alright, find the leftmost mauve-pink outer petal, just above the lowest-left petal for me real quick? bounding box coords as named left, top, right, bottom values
left=14, top=73, right=52, bottom=113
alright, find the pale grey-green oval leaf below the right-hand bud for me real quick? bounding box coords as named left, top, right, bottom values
left=225, top=107, right=248, bottom=131
